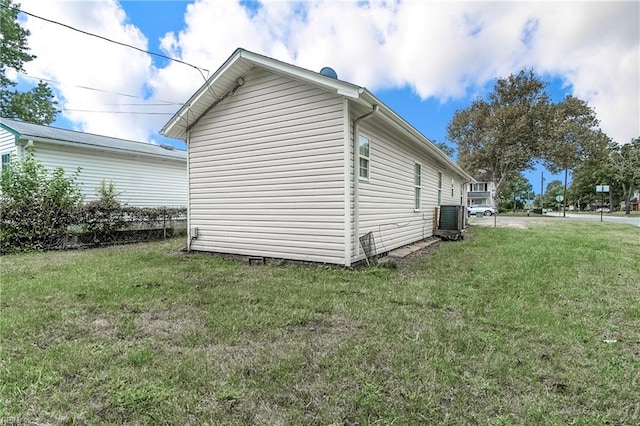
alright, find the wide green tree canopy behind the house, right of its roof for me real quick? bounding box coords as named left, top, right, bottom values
left=447, top=70, right=624, bottom=215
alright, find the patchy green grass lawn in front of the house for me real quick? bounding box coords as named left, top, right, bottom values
left=0, top=222, right=640, bottom=425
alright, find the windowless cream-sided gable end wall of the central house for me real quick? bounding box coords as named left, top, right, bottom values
left=188, top=69, right=345, bottom=264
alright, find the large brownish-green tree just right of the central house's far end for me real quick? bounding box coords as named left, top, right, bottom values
left=447, top=70, right=550, bottom=205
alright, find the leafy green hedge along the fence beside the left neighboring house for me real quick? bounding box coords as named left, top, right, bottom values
left=0, top=151, right=186, bottom=254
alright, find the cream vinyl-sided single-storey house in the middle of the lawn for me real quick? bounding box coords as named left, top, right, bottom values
left=161, top=49, right=473, bottom=266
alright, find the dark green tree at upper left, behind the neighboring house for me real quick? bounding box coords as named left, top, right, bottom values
left=0, top=0, right=57, bottom=124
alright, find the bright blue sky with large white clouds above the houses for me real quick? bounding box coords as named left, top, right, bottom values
left=16, top=0, right=640, bottom=193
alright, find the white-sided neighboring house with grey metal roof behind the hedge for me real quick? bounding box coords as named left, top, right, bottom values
left=0, top=118, right=187, bottom=207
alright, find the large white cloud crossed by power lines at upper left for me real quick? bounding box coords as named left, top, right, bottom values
left=21, top=0, right=152, bottom=140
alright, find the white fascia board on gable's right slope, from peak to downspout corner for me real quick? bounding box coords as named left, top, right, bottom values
left=240, top=50, right=363, bottom=99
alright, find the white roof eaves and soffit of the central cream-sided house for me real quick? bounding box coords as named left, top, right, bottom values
left=160, top=49, right=474, bottom=181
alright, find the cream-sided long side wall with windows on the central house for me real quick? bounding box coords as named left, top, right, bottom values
left=351, top=108, right=465, bottom=260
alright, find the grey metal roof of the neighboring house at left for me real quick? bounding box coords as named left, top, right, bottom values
left=0, top=118, right=187, bottom=160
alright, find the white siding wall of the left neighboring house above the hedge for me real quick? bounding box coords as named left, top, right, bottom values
left=33, top=141, right=187, bottom=207
